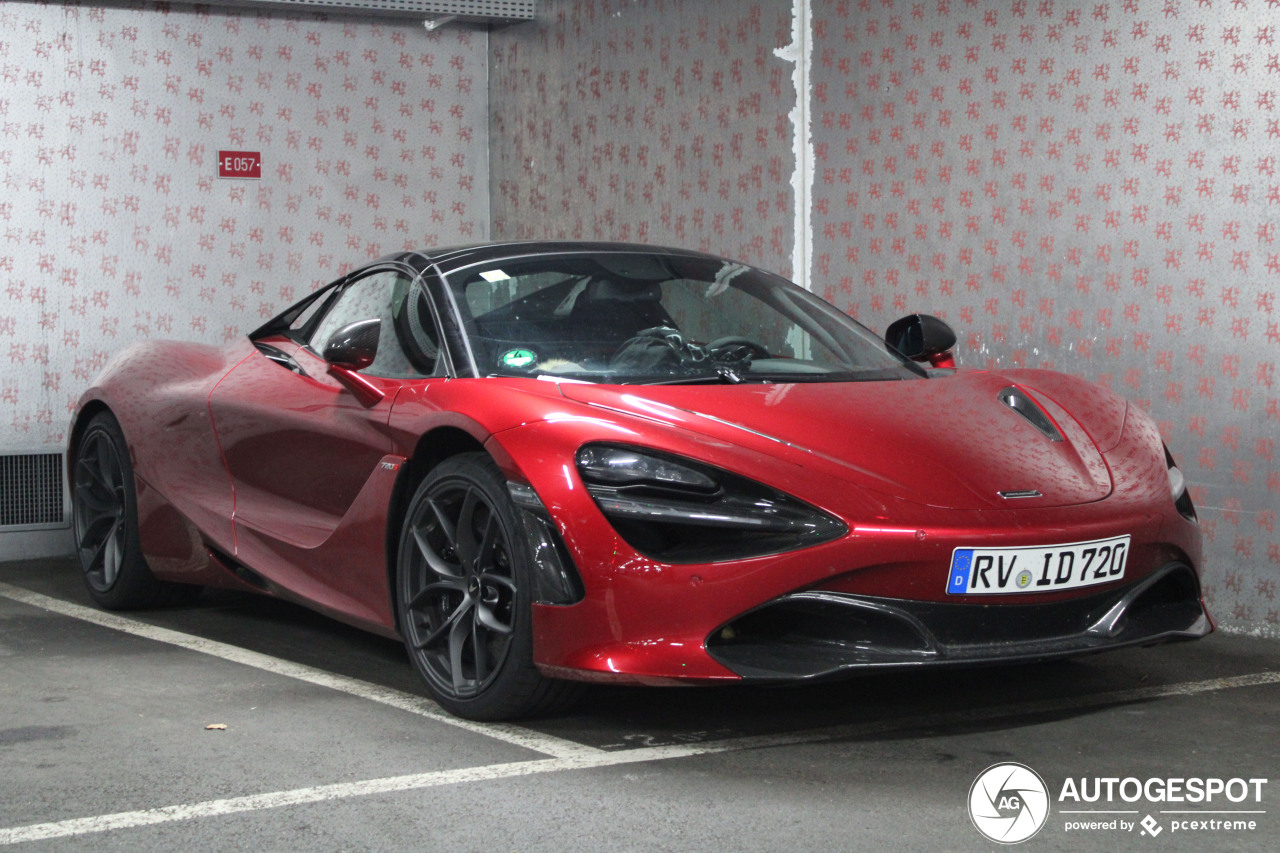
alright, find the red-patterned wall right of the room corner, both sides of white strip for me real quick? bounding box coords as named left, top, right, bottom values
left=490, top=0, right=1280, bottom=635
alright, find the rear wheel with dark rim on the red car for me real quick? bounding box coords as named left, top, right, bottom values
left=72, top=411, right=201, bottom=610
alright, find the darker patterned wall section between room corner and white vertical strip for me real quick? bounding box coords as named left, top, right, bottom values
left=489, top=0, right=796, bottom=273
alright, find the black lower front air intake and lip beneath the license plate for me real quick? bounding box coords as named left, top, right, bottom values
left=707, top=562, right=1213, bottom=681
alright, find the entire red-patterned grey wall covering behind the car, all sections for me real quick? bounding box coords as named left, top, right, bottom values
left=0, top=0, right=1280, bottom=635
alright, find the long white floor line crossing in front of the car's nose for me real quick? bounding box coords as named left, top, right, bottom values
left=0, top=671, right=1280, bottom=847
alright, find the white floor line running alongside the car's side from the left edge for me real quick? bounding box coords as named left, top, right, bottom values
left=0, top=583, right=593, bottom=758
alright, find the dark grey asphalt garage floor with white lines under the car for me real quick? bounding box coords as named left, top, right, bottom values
left=0, top=560, right=1280, bottom=853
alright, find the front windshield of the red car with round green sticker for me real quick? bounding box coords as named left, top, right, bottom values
left=448, top=252, right=923, bottom=384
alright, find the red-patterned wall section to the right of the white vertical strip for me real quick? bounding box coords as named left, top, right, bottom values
left=813, top=0, right=1280, bottom=634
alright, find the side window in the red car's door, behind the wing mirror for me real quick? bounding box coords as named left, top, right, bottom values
left=308, top=270, right=439, bottom=378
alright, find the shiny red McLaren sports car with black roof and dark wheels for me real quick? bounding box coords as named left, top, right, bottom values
left=69, top=243, right=1212, bottom=720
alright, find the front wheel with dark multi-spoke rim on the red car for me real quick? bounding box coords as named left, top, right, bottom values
left=396, top=453, right=581, bottom=721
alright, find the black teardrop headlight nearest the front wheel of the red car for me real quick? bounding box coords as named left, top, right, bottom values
left=577, top=444, right=847, bottom=562
